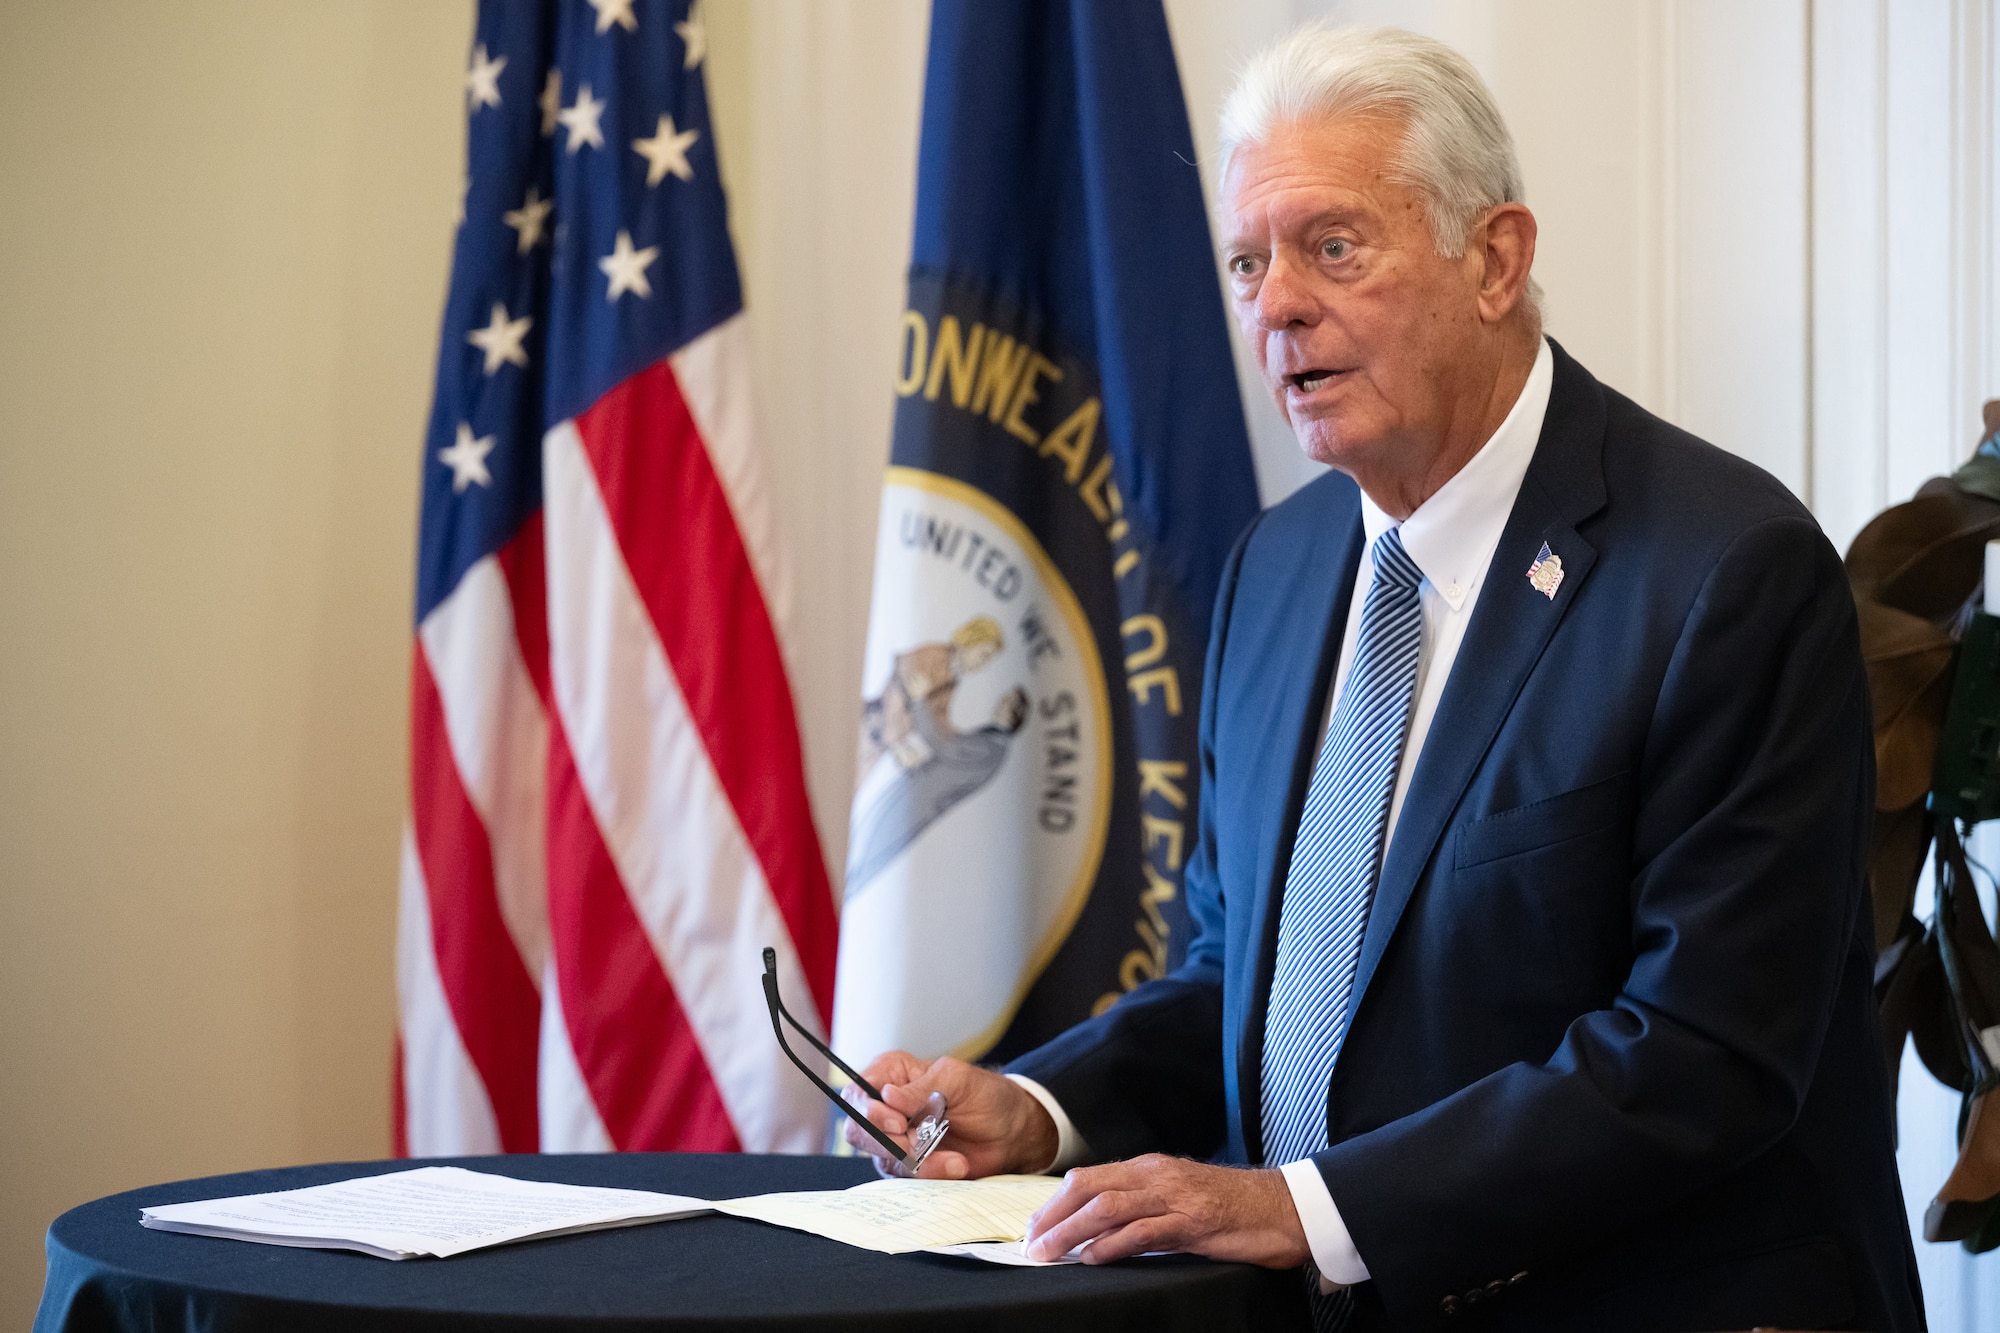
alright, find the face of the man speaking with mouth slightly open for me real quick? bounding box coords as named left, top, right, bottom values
left=1222, top=118, right=1484, bottom=478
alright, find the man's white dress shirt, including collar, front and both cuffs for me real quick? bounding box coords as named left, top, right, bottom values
left=1008, top=340, right=1556, bottom=1289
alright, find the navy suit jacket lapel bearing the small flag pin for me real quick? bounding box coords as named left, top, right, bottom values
left=1344, top=342, right=1604, bottom=1015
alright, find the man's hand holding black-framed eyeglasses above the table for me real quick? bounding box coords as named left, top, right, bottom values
left=846, top=1051, right=1056, bottom=1181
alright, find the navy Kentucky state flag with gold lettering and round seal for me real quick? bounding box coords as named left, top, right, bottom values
left=834, top=0, right=1258, bottom=1059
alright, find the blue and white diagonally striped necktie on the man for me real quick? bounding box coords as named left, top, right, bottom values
left=1262, top=528, right=1424, bottom=1331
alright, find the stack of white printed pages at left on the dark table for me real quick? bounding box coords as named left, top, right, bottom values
left=140, top=1167, right=710, bottom=1259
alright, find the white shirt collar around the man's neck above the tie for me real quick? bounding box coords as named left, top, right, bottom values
left=1362, top=338, right=1556, bottom=610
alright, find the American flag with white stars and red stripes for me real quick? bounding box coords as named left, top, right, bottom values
left=396, top=0, right=834, bottom=1157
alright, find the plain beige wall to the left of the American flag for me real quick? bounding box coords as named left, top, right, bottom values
left=0, top=0, right=468, bottom=1327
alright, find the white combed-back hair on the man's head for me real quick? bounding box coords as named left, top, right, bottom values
left=1222, top=24, right=1540, bottom=286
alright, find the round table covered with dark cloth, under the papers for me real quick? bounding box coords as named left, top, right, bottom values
left=34, top=1153, right=1308, bottom=1333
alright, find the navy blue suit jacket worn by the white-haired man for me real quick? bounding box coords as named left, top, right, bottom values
left=1012, top=348, right=1922, bottom=1331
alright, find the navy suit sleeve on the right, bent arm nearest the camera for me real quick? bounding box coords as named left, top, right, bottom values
left=1314, top=514, right=1874, bottom=1307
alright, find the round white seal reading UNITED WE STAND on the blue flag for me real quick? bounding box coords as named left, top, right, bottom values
left=834, top=466, right=1114, bottom=1055
